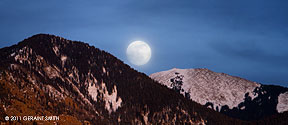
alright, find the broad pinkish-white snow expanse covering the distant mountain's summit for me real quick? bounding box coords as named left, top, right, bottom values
left=150, top=68, right=260, bottom=111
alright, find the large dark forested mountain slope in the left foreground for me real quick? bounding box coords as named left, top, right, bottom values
left=0, top=34, right=241, bottom=124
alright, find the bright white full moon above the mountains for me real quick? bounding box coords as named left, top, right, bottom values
left=126, top=41, right=151, bottom=66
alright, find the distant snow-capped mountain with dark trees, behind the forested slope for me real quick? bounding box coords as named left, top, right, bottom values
left=150, top=68, right=288, bottom=120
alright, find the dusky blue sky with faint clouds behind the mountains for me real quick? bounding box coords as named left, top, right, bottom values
left=0, top=0, right=288, bottom=87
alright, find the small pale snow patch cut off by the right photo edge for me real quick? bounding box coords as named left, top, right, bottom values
left=277, top=92, right=288, bottom=113
